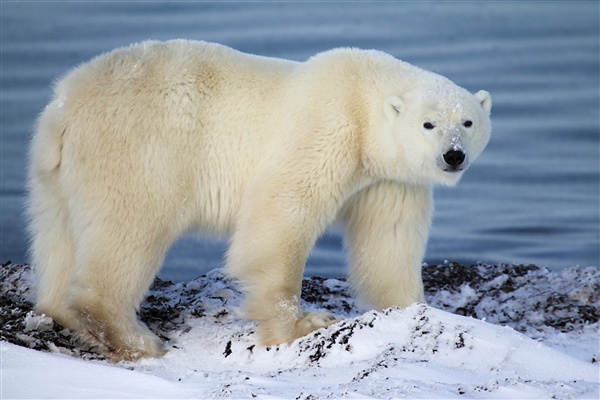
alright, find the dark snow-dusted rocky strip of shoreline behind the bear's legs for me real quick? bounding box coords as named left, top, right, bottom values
left=0, top=262, right=600, bottom=363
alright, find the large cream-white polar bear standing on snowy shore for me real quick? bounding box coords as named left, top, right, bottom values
left=28, top=40, right=491, bottom=361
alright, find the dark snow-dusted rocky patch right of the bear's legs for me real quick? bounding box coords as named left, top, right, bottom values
left=423, top=263, right=600, bottom=333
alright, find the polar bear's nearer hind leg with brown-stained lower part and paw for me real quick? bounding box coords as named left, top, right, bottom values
left=71, top=213, right=170, bottom=361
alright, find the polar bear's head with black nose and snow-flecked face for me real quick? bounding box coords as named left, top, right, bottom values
left=383, top=84, right=492, bottom=185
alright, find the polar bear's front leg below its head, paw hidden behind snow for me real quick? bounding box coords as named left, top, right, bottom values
left=342, top=182, right=432, bottom=309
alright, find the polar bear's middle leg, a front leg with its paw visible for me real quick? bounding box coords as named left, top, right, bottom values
left=227, top=186, right=337, bottom=345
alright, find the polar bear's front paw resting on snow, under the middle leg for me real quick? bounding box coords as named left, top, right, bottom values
left=258, top=312, right=340, bottom=346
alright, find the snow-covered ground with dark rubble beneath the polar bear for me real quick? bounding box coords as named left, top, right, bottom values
left=0, top=263, right=600, bottom=399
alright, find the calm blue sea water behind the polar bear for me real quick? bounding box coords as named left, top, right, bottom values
left=0, top=1, right=600, bottom=280
